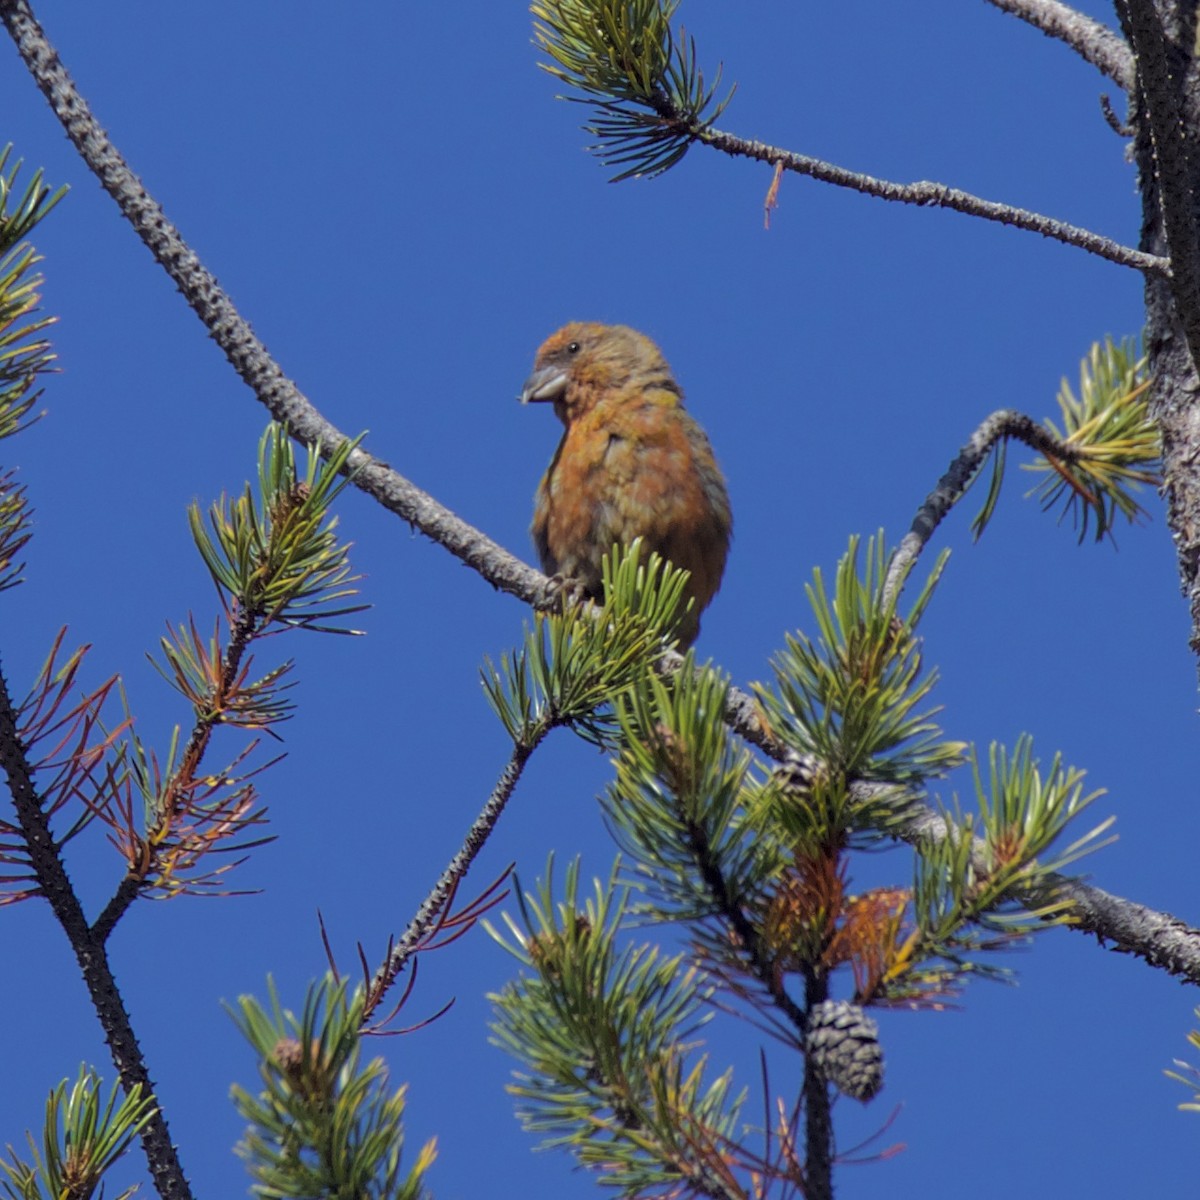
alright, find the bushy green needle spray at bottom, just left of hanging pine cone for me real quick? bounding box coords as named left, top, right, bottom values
left=488, top=860, right=744, bottom=1198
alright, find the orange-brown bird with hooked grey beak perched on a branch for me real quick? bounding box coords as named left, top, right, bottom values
left=521, top=322, right=733, bottom=647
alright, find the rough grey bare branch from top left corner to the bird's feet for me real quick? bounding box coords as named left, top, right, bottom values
left=0, top=0, right=552, bottom=606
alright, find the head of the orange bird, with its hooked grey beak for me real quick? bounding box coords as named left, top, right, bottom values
left=521, top=322, right=680, bottom=425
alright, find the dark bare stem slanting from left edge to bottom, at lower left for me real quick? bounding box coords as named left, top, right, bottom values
left=0, top=673, right=192, bottom=1200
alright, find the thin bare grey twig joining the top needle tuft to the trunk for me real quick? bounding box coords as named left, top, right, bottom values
left=696, top=118, right=1171, bottom=275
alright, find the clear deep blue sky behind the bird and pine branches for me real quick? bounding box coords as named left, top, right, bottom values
left=0, top=0, right=1200, bottom=1200
